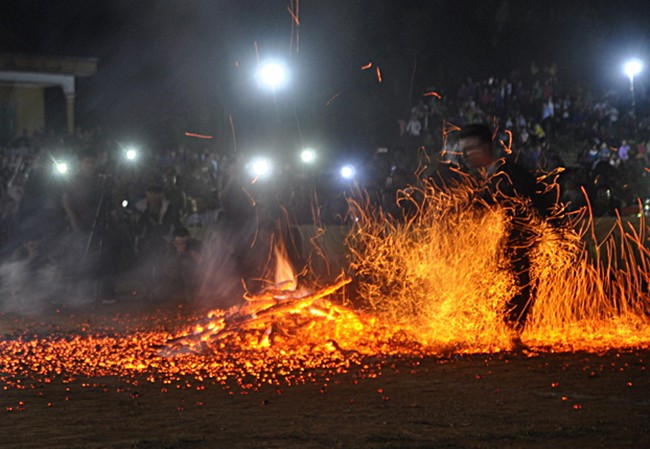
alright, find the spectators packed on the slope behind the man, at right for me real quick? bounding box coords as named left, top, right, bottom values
left=400, top=62, right=650, bottom=215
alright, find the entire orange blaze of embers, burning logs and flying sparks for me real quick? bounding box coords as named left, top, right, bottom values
left=0, top=182, right=650, bottom=389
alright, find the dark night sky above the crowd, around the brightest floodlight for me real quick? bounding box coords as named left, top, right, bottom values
left=0, top=0, right=650, bottom=150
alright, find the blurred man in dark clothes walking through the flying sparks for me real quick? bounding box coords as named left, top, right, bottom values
left=458, top=123, right=552, bottom=332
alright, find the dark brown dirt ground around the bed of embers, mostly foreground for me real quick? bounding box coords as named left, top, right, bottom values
left=0, top=304, right=650, bottom=449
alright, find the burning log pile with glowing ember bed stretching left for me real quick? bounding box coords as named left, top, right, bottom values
left=0, top=248, right=419, bottom=389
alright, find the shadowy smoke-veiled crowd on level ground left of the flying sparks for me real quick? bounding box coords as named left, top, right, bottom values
left=0, top=119, right=378, bottom=310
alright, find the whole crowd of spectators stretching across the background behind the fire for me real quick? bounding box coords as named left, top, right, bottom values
left=0, top=60, right=650, bottom=305
